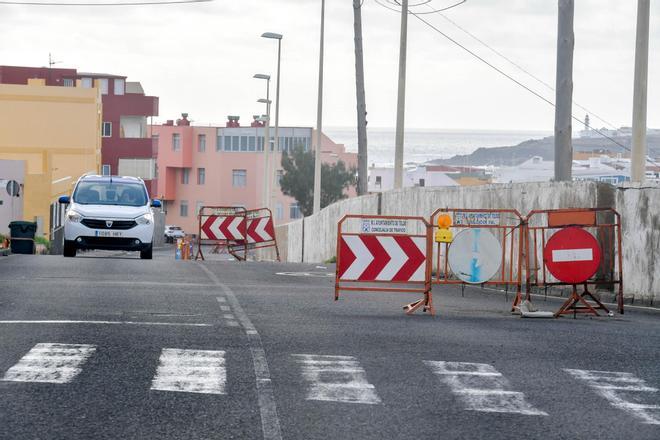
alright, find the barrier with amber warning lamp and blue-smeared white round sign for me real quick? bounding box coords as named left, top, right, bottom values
left=430, top=208, right=524, bottom=311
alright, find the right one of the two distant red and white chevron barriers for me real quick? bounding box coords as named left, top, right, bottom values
left=227, top=208, right=280, bottom=261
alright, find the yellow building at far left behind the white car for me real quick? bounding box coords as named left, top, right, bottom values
left=0, top=79, right=102, bottom=236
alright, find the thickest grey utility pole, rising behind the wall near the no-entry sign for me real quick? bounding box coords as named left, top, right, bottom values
left=555, top=0, right=575, bottom=181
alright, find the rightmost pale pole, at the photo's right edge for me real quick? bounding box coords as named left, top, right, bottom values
left=630, top=0, right=650, bottom=183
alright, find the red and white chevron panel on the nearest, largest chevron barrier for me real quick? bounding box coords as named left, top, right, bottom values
left=339, top=234, right=426, bottom=282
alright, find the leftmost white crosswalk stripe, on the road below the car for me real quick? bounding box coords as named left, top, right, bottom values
left=2, top=343, right=96, bottom=383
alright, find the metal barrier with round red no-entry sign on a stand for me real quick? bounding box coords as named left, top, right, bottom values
left=525, top=208, right=623, bottom=317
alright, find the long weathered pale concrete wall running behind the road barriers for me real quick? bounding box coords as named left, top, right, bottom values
left=276, top=182, right=660, bottom=303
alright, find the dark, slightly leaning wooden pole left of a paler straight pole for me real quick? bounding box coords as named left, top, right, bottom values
left=353, top=0, right=369, bottom=196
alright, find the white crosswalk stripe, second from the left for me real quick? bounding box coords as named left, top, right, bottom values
left=151, top=348, right=227, bottom=394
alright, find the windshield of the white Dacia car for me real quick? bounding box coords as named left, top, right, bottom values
left=73, top=181, right=148, bottom=206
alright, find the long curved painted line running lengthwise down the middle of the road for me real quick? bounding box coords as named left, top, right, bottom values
left=199, top=264, right=282, bottom=440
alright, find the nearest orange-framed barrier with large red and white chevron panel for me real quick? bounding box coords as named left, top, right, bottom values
left=335, top=215, right=435, bottom=315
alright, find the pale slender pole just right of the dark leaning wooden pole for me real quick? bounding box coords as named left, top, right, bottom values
left=394, top=0, right=408, bottom=189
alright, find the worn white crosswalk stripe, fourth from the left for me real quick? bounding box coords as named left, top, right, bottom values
left=424, top=361, right=548, bottom=416
